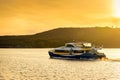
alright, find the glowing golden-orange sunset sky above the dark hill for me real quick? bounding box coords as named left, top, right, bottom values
left=0, top=0, right=120, bottom=35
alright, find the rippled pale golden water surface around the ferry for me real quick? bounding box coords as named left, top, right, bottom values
left=0, top=48, right=120, bottom=80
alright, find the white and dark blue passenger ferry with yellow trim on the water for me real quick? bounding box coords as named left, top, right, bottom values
left=48, top=42, right=106, bottom=59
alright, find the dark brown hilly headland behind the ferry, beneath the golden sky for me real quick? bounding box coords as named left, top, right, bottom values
left=0, top=27, right=120, bottom=48
